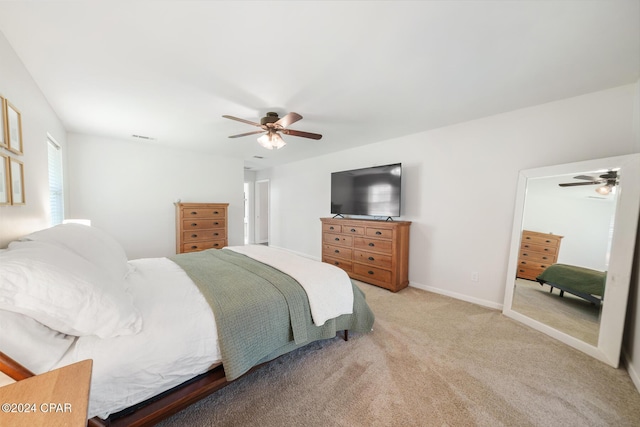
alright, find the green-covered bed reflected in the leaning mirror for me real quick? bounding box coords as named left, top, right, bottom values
left=536, top=264, right=607, bottom=305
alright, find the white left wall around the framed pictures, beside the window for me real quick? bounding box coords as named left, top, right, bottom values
left=0, top=33, right=66, bottom=248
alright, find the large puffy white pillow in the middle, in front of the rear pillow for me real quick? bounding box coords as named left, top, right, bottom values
left=0, top=242, right=142, bottom=338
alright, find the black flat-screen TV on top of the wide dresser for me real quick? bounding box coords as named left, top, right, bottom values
left=331, top=163, right=402, bottom=217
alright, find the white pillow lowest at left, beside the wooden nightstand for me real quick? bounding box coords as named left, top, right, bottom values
left=0, top=310, right=75, bottom=374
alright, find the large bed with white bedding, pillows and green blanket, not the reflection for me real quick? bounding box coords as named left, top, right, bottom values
left=0, top=224, right=374, bottom=425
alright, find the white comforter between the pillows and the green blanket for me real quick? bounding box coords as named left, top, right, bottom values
left=53, top=258, right=221, bottom=418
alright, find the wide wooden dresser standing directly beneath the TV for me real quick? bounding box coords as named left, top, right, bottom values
left=320, top=218, right=411, bottom=292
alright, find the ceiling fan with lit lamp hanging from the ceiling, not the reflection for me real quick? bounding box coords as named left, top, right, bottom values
left=222, top=112, right=322, bottom=150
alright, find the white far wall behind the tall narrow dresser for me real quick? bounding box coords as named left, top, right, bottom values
left=68, top=134, right=244, bottom=258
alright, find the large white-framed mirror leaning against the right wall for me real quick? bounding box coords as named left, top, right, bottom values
left=503, top=154, right=640, bottom=368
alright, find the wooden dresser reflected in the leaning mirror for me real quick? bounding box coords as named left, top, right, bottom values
left=516, top=230, right=563, bottom=280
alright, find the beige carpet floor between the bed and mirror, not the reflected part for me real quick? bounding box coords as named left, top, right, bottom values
left=159, top=284, right=640, bottom=427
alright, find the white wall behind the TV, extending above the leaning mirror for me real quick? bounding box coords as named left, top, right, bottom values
left=257, top=85, right=637, bottom=308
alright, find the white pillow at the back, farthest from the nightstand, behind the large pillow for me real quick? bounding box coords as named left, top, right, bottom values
left=20, top=223, right=131, bottom=280
